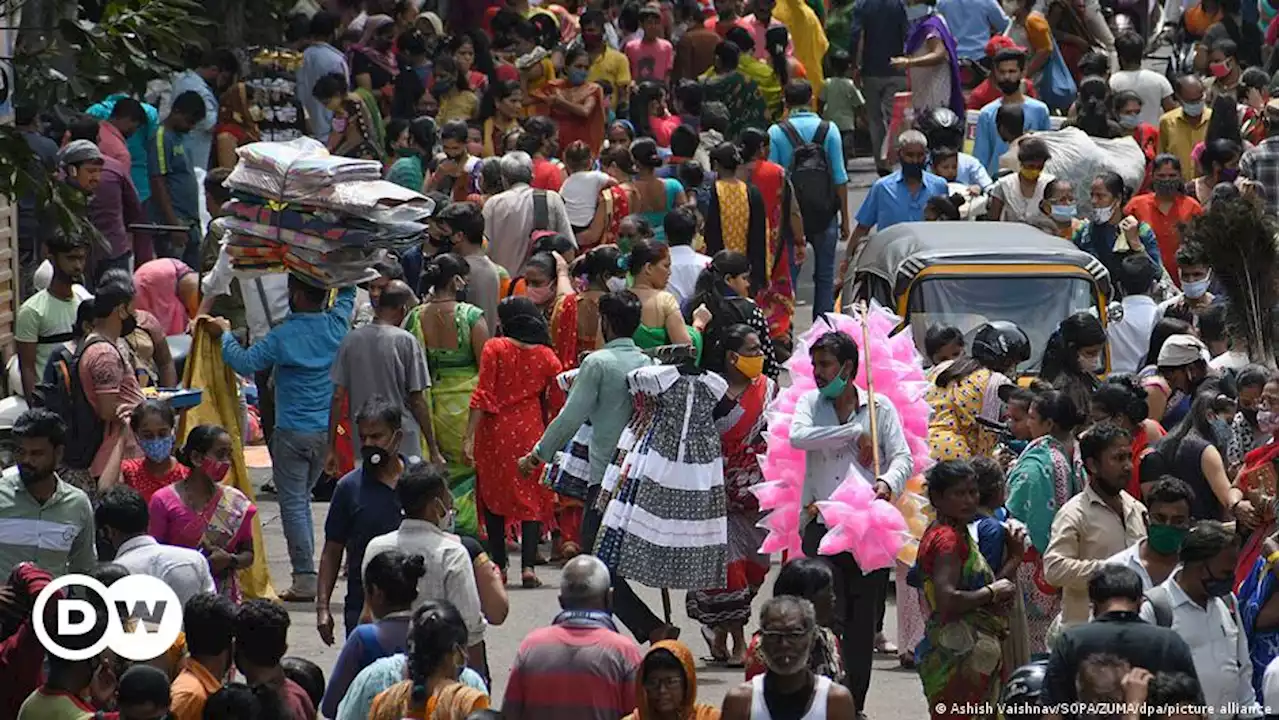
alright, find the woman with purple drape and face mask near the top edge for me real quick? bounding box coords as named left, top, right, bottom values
left=890, top=0, right=964, bottom=118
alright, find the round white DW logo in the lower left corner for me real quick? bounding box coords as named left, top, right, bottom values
left=32, top=575, right=182, bottom=661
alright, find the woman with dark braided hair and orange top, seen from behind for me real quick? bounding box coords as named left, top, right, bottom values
left=369, top=600, right=489, bottom=720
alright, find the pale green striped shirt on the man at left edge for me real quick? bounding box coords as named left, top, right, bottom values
left=0, top=468, right=97, bottom=578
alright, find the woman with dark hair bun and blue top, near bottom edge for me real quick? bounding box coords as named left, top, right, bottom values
left=320, top=550, right=426, bottom=717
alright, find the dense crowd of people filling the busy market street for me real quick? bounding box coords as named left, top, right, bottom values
left=0, top=0, right=1280, bottom=720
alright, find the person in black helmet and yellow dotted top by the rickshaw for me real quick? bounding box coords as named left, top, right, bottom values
left=924, top=320, right=1032, bottom=460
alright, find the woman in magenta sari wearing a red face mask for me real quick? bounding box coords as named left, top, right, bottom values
left=148, top=425, right=257, bottom=603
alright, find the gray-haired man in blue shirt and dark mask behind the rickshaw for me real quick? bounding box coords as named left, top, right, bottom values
left=836, top=129, right=947, bottom=283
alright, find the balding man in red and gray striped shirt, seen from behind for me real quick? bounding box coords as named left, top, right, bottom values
left=502, top=555, right=643, bottom=720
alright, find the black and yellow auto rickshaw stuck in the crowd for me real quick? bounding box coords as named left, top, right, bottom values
left=841, top=222, right=1119, bottom=374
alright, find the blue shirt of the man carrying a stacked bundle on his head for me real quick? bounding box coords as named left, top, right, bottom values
left=223, top=287, right=355, bottom=430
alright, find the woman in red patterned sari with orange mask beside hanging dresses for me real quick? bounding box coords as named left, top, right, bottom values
left=685, top=324, right=777, bottom=667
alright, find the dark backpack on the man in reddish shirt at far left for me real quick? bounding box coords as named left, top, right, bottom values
left=33, top=337, right=120, bottom=469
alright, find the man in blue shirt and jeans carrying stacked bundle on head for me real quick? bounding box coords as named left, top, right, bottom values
left=219, top=274, right=356, bottom=602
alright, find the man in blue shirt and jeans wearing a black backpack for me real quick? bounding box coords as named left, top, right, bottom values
left=769, top=79, right=852, bottom=318
